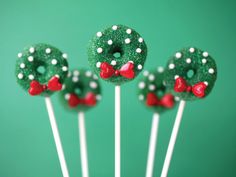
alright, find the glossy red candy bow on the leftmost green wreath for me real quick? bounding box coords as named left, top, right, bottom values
left=28, top=76, right=62, bottom=96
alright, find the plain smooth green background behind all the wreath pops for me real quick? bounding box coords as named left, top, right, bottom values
left=0, top=0, right=236, bottom=177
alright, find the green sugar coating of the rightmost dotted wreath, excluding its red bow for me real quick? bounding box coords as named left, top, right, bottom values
left=165, top=47, right=217, bottom=101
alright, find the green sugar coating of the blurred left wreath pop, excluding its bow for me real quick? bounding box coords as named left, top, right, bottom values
left=60, top=69, right=102, bottom=112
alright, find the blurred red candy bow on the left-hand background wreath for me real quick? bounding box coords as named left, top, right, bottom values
left=68, top=92, right=97, bottom=108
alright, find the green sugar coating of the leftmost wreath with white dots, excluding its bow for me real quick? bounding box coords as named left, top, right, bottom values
left=15, top=44, right=68, bottom=96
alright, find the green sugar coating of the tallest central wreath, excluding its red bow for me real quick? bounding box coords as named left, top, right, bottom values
left=88, top=25, right=147, bottom=85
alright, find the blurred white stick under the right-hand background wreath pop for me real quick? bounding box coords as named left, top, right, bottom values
left=146, top=113, right=160, bottom=177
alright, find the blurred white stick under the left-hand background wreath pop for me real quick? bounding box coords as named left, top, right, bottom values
left=78, top=112, right=89, bottom=177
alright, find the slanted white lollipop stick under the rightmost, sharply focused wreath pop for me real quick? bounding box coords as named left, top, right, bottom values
left=161, top=100, right=186, bottom=177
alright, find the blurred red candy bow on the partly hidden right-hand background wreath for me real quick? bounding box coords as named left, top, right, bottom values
left=146, top=93, right=174, bottom=108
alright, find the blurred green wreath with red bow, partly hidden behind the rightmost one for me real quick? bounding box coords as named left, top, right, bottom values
left=138, top=67, right=175, bottom=113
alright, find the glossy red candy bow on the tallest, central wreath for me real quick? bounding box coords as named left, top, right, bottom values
left=100, top=62, right=135, bottom=79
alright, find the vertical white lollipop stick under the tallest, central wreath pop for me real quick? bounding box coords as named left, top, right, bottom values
left=115, top=85, right=120, bottom=177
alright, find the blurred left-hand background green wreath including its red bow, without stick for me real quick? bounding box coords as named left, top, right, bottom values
left=60, top=69, right=101, bottom=112
